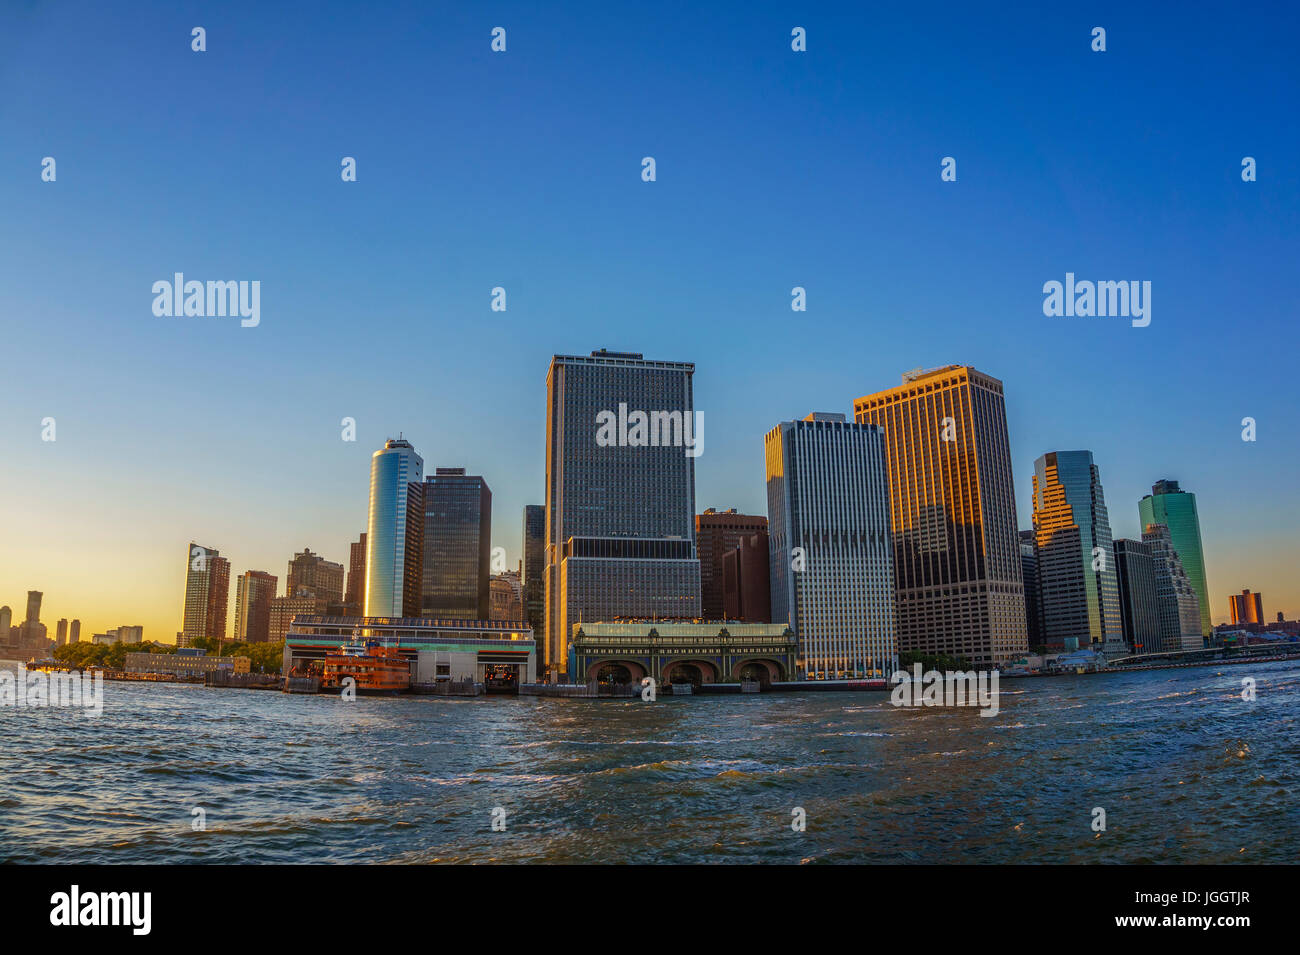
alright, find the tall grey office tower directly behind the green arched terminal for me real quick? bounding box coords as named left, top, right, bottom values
left=546, top=350, right=703, bottom=674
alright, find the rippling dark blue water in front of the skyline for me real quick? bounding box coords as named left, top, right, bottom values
left=0, top=661, right=1300, bottom=864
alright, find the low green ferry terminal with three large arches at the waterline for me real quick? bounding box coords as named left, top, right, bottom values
left=571, top=620, right=798, bottom=686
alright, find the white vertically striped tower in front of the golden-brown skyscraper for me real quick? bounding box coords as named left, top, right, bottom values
left=764, top=412, right=898, bottom=680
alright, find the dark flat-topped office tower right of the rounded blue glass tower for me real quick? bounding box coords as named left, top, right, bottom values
left=419, top=468, right=491, bottom=620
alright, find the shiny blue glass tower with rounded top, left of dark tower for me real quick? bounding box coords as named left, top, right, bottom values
left=364, top=438, right=424, bottom=617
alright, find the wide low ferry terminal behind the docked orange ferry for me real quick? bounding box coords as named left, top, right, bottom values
left=281, top=615, right=537, bottom=686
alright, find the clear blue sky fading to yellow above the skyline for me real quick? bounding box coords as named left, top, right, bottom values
left=0, top=0, right=1300, bottom=641
